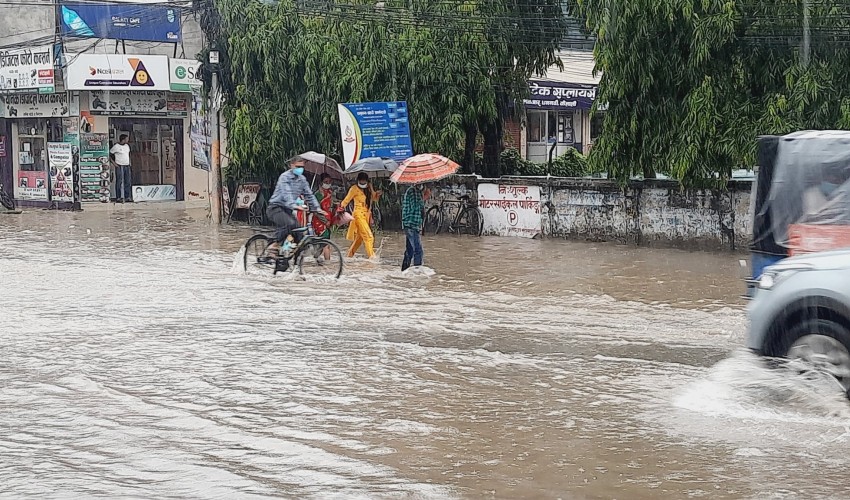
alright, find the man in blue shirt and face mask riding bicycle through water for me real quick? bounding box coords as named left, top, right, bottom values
left=266, top=157, right=328, bottom=258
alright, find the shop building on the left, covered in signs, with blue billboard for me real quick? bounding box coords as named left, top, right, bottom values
left=0, top=2, right=209, bottom=209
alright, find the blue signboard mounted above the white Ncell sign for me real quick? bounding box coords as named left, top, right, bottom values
left=60, top=3, right=181, bottom=43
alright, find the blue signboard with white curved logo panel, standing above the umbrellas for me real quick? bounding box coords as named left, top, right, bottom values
left=338, top=101, right=413, bottom=168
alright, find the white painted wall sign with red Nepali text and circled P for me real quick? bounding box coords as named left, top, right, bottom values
left=478, top=184, right=542, bottom=238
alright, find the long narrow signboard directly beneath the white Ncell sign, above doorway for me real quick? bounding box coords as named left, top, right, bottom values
left=89, top=90, right=188, bottom=116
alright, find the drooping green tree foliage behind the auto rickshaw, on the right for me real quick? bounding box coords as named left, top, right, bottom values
left=579, top=0, right=850, bottom=184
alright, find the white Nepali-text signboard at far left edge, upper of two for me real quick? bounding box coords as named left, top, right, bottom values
left=0, top=45, right=55, bottom=94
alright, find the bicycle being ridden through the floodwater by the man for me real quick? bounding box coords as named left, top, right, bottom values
left=242, top=213, right=343, bottom=279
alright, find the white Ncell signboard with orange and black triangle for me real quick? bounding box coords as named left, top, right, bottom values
left=65, top=54, right=171, bottom=90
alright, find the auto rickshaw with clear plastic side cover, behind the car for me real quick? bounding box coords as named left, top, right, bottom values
left=747, top=130, right=850, bottom=296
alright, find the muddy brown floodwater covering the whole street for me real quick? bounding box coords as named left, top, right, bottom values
left=0, top=205, right=850, bottom=499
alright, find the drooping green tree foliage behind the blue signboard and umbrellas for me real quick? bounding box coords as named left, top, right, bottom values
left=195, top=0, right=563, bottom=184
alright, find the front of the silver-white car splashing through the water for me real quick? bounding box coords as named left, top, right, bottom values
left=747, top=249, right=850, bottom=396
